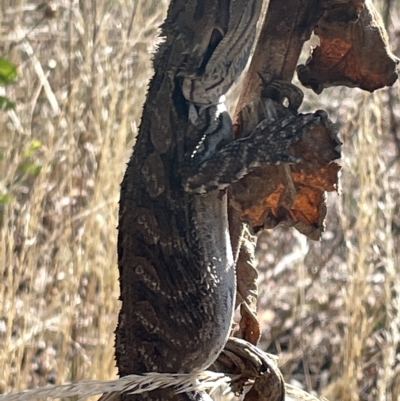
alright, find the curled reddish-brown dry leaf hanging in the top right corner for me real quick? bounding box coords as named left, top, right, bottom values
left=297, top=0, right=399, bottom=93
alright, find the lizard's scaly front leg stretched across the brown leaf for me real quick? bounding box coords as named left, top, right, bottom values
left=184, top=107, right=322, bottom=194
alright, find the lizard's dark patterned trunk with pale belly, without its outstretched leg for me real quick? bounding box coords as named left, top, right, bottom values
left=116, top=0, right=258, bottom=400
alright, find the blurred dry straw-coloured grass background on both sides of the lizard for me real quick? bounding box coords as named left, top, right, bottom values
left=0, top=0, right=400, bottom=401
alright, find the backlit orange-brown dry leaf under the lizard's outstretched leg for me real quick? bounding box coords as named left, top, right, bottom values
left=231, top=104, right=340, bottom=240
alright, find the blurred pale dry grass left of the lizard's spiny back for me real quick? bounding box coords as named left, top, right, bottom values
left=0, top=0, right=168, bottom=391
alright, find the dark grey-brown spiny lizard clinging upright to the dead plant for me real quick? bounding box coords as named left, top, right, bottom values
left=112, top=0, right=322, bottom=400
